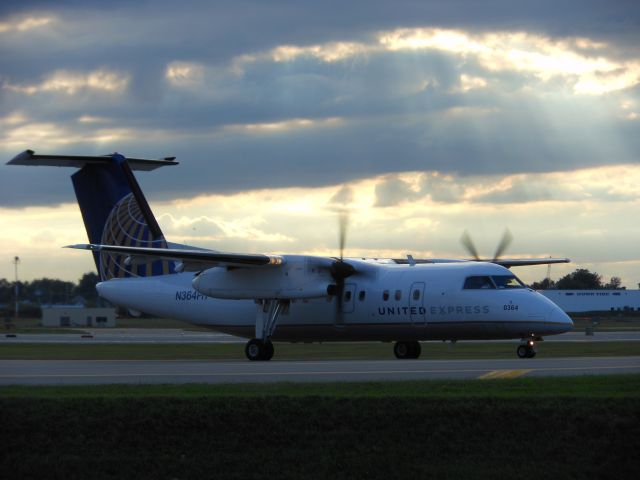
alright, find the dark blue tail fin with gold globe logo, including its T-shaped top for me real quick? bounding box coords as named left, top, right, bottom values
left=9, top=150, right=177, bottom=280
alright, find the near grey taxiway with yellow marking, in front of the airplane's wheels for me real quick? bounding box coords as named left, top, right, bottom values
left=0, top=356, right=640, bottom=385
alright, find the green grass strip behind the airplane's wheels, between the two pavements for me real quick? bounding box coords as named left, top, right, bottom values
left=0, top=340, right=640, bottom=360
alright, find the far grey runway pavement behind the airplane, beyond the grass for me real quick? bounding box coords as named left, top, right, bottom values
left=0, top=328, right=640, bottom=345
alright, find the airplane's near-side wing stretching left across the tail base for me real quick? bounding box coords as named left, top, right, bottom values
left=65, top=244, right=283, bottom=268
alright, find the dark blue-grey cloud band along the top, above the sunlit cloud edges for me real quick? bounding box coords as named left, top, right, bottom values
left=0, top=0, right=640, bottom=86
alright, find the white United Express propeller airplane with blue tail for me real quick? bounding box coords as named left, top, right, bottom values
left=8, top=150, right=573, bottom=361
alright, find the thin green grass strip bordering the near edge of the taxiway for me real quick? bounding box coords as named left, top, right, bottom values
left=0, top=374, right=640, bottom=401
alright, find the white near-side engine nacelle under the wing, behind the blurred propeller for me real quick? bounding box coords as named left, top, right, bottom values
left=192, top=255, right=334, bottom=300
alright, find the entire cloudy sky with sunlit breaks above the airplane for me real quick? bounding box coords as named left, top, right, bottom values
left=0, top=0, right=640, bottom=288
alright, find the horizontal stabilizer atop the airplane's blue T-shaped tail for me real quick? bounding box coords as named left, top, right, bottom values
left=7, top=150, right=178, bottom=171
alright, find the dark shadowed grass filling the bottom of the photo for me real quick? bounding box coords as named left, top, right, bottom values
left=0, top=396, right=640, bottom=479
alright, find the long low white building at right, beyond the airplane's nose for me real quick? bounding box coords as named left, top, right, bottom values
left=538, top=290, right=640, bottom=313
